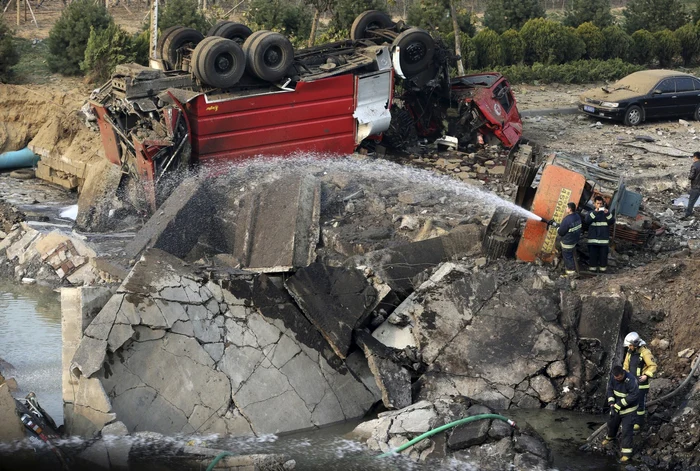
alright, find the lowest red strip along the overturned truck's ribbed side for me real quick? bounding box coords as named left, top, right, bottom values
left=199, top=134, right=355, bottom=166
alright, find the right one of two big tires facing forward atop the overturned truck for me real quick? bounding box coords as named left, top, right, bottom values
left=243, top=31, right=294, bottom=82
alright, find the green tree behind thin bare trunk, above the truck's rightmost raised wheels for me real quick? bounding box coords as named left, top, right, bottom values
left=406, top=0, right=476, bottom=38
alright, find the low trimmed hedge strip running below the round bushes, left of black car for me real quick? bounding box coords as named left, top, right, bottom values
left=470, top=59, right=643, bottom=85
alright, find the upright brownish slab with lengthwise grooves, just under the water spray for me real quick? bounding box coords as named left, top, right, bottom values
left=233, top=175, right=321, bottom=272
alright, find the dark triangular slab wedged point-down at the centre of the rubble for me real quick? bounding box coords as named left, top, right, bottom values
left=285, top=263, right=378, bottom=359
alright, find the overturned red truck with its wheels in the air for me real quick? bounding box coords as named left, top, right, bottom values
left=90, top=10, right=522, bottom=209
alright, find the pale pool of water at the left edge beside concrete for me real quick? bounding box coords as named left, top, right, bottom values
left=0, top=281, right=63, bottom=424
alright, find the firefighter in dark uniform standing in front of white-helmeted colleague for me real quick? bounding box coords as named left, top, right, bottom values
left=602, top=365, right=639, bottom=463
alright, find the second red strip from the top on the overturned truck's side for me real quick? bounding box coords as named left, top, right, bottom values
left=192, top=96, right=354, bottom=136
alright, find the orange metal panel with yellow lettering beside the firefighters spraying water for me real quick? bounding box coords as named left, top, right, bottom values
left=515, top=165, right=586, bottom=262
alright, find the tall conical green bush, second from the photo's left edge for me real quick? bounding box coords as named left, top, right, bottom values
left=47, top=0, right=112, bottom=75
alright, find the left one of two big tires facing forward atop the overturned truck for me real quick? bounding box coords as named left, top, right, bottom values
left=192, top=37, right=246, bottom=88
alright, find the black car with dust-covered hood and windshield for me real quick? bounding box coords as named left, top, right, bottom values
left=578, top=70, right=700, bottom=126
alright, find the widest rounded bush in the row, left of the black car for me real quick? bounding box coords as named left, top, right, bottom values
left=520, top=18, right=586, bottom=64
